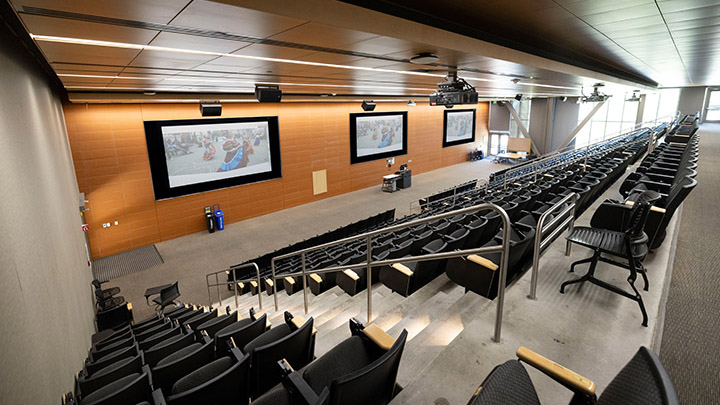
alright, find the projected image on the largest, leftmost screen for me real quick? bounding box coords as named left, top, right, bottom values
left=162, top=122, right=271, bottom=187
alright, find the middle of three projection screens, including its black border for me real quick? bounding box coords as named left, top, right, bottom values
left=350, top=111, right=407, bottom=163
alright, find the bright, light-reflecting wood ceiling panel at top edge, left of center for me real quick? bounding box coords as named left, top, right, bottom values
left=172, top=0, right=306, bottom=38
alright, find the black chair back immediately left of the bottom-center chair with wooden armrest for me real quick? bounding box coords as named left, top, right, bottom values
left=245, top=317, right=315, bottom=398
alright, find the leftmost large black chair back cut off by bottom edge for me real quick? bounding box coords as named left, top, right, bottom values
left=80, top=373, right=152, bottom=405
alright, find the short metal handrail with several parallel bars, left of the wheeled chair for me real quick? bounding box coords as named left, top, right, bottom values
left=528, top=193, right=578, bottom=300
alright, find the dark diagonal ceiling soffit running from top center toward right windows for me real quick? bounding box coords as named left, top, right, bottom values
left=340, top=0, right=658, bottom=87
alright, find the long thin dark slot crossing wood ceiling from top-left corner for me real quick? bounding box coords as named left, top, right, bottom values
left=19, top=5, right=529, bottom=79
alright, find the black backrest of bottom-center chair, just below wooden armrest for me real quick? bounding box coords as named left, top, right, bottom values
left=328, top=330, right=407, bottom=405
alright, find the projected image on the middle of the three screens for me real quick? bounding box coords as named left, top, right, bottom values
left=356, top=115, right=405, bottom=156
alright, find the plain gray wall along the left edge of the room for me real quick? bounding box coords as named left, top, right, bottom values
left=0, top=20, right=94, bottom=404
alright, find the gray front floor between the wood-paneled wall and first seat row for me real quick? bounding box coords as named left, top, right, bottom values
left=109, top=159, right=498, bottom=319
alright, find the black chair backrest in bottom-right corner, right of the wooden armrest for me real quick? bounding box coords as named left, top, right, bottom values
left=597, top=346, right=680, bottom=405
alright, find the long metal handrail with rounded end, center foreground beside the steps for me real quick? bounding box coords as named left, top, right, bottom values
left=270, top=203, right=510, bottom=342
